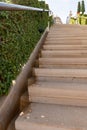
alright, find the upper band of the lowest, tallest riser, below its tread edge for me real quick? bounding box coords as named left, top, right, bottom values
left=29, top=86, right=87, bottom=100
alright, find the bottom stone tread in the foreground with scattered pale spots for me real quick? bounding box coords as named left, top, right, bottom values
left=15, top=103, right=87, bottom=130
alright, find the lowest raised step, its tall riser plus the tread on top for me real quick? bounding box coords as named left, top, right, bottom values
left=28, top=82, right=87, bottom=106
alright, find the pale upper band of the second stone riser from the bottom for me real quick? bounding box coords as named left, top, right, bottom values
left=33, top=68, right=87, bottom=79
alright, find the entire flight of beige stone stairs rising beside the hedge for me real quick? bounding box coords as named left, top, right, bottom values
left=15, top=25, right=87, bottom=130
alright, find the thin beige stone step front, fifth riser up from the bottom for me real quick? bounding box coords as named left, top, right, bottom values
left=43, top=44, right=87, bottom=50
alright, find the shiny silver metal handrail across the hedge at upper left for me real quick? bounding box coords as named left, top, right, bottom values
left=0, top=2, right=49, bottom=12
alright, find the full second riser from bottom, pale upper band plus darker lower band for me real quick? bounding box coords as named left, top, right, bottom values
left=33, top=69, right=87, bottom=83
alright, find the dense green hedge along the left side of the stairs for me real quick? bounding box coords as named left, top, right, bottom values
left=0, top=0, right=49, bottom=95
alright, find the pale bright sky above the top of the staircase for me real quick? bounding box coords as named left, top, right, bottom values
left=45, top=0, right=87, bottom=23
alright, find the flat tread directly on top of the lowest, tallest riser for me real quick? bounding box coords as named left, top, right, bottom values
left=29, top=82, right=87, bottom=91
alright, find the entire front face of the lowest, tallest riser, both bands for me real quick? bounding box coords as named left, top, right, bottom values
left=29, top=87, right=87, bottom=106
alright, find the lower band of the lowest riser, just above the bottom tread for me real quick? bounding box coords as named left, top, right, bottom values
left=30, top=97, right=87, bottom=107
